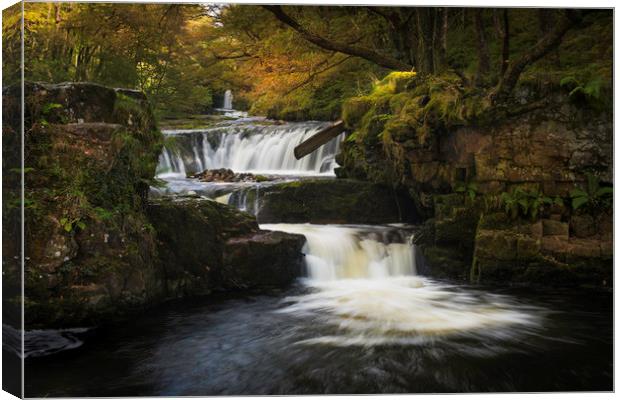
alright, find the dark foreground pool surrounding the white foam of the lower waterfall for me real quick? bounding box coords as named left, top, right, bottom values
left=25, top=287, right=613, bottom=397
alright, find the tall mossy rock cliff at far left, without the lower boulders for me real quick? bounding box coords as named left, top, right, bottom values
left=3, top=83, right=162, bottom=326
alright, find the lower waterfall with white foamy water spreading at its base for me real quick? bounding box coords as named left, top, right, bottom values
left=261, top=224, right=541, bottom=351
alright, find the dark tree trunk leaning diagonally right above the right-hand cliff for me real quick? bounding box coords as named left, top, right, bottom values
left=491, top=10, right=579, bottom=103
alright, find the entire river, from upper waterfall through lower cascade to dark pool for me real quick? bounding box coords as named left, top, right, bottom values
left=26, top=114, right=613, bottom=397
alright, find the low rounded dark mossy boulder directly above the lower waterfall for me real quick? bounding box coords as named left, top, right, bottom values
left=256, top=179, right=415, bottom=224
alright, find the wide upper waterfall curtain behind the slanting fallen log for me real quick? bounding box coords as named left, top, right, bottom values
left=157, top=122, right=342, bottom=175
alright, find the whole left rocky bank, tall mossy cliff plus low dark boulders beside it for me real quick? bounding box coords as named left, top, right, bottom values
left=3, top=83, right=303, bottom=328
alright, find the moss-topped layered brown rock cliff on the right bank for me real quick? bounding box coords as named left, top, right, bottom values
left=338, top=76, right=613, bottom=285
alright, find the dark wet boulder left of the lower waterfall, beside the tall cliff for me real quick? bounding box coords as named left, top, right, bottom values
left=148, top=198, right=305, bottom=297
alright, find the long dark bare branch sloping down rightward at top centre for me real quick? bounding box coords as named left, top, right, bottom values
left=262, top=5, right=413, bottom=71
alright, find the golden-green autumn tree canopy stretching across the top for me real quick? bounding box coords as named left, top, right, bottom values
left=3, top=3, right=613, bottom=119
